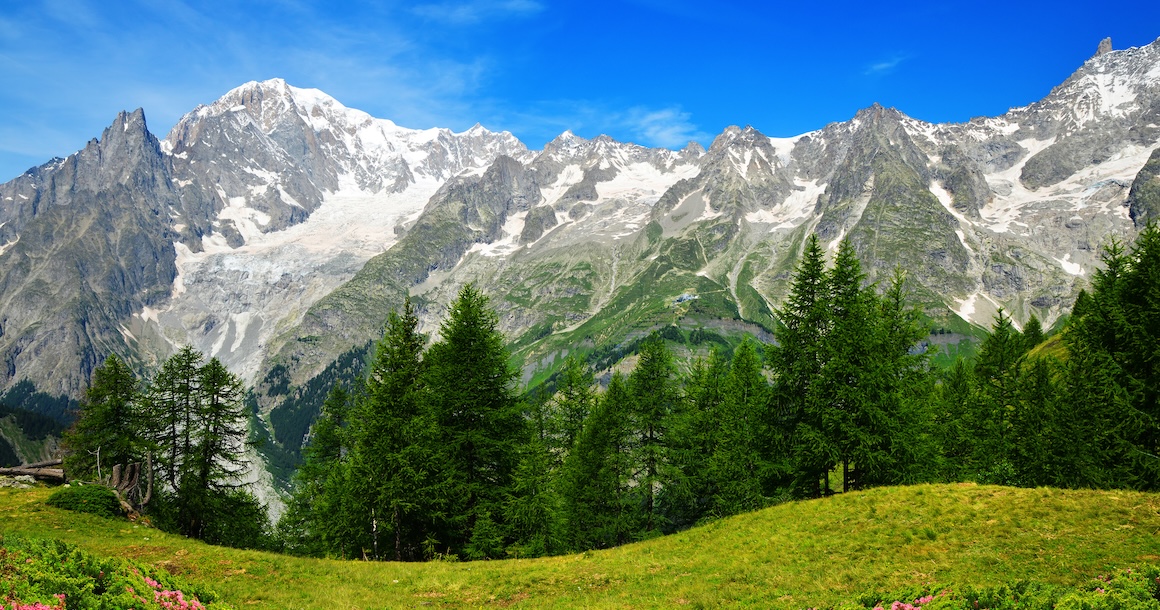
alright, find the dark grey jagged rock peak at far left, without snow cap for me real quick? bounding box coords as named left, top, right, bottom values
left=0, top=110, right=183, bottom=395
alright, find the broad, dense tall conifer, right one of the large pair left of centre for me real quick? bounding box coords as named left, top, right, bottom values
left=422, top=284, right=528, bottom=552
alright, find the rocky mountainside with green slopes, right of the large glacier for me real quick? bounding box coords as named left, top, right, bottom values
left=263, top=38, right=1160, bottom=417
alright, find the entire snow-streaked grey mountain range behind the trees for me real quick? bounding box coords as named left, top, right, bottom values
left=0, top=37, right=1160, bottom=415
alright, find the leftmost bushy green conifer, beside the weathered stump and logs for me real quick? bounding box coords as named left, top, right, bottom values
left=64, top=355, right=145, bottom=480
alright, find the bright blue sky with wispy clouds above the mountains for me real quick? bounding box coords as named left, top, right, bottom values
left=0, top=0, right=1160, bottom=181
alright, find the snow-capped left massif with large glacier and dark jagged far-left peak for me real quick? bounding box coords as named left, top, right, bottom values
left=0, top=80, right=525, bottom=398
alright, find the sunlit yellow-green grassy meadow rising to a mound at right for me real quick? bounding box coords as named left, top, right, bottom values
left=0, top=485, right=1160, bottom=608
